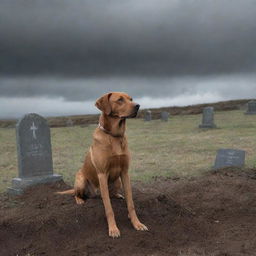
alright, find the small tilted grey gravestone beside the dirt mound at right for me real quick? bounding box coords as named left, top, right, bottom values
left=214, top=149, right=245, bottom=169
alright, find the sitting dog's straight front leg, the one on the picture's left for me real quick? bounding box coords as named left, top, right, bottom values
left=98, top=173, right=120, bottom=238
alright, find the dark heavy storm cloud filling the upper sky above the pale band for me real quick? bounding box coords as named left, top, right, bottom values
left=0, top=0, right=256, bottom=76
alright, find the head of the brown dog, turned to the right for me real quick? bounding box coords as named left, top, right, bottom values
left=95, top=92, right=140, bottom=118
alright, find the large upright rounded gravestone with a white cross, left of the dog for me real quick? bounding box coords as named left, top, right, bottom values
left=8, top=114, right=62, bottom=194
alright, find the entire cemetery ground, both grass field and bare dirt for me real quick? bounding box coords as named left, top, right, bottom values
left=0, top=110, right=256, bottom=256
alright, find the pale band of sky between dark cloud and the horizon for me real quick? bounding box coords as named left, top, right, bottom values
left=0, top=75, right=256, bottom=118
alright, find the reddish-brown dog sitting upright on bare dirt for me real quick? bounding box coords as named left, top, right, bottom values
left=57, top=92, right=148, bottom=238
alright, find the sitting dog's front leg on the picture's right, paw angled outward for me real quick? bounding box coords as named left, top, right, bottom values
left=121, top=171, right=148, bottom=231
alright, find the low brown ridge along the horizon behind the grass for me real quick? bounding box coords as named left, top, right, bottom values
left=0, top=99, right=252, bottom=128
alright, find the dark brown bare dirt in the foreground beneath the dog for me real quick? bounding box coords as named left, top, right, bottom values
left=0, top=169, right=256, bottom=256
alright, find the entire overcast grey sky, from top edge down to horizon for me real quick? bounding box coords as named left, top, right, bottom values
left=0, top=0, right=256, bottom=118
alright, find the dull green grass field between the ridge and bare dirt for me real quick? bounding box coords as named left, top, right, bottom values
left=0, top=110, right=256, bottom=193
